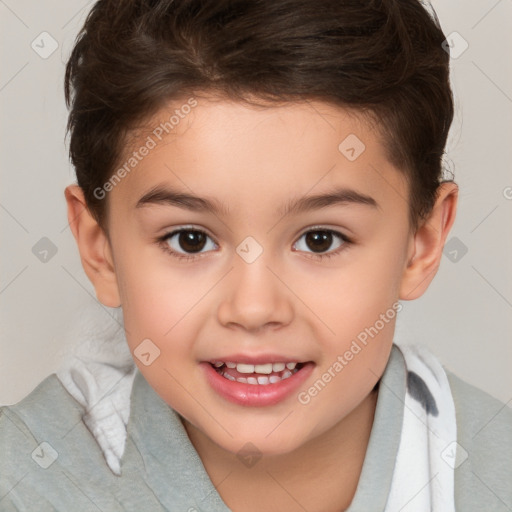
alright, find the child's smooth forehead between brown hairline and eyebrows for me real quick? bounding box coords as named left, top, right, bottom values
left=112, top=97, right=407, bottom=218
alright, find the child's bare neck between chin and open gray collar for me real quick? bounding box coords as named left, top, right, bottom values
left=182, top=388, right=378, bottom=512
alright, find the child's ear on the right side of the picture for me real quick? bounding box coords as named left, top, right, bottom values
left=400, top=182, right=459, bottom=300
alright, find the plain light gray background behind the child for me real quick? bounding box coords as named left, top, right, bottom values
left=0, top=0, right=512, bottom=405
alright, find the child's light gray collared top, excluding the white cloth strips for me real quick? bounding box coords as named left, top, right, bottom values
left=0, top=345, right=512, bottom=512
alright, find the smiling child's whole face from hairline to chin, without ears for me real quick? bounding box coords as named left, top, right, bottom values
left=102, top=99, right=414, bottom=454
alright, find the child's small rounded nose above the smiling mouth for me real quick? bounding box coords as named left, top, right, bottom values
left=217, top=252, right=294, bottom=332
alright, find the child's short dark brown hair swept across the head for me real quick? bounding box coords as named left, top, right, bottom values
left=65, top=0, right=453, bottom=227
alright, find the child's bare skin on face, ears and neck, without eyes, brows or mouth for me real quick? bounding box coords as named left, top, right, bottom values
left=65, top=97, right=457, bottom=512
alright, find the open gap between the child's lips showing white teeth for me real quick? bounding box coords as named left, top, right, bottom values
left=210, top=361, right=305, bottom=386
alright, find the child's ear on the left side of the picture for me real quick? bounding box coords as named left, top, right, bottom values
left=64, top=185, right=121, bottom=308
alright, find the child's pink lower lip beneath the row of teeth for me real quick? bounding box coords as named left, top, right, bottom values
left=200, top=362, right=315, bottom=407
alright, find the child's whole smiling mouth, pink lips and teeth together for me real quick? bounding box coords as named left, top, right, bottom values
left=200, top=356, right=315, bottom=407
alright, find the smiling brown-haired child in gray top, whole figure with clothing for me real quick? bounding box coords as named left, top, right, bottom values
left=0, top=0, right=512, bottom=512
